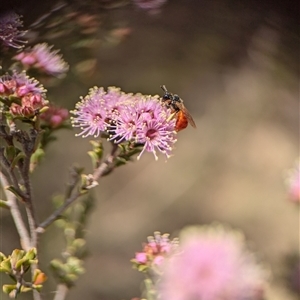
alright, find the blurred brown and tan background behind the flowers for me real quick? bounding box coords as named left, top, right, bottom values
left=0, top=0, right=299, bottom=300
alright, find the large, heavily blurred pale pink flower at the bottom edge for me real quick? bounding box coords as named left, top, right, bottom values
left=158, top=225, right=266, bottom=300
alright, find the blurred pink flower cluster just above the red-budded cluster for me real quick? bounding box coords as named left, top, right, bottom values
left=14, top=43, right=69, bottom=76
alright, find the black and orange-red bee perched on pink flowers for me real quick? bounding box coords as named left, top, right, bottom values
left=161, top=85, right=196, bottom=131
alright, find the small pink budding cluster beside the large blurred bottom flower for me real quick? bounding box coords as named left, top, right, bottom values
left=131, top=231, right=178, bottom=272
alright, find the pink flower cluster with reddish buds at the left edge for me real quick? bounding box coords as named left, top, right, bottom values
left=0, top=72, right=48, bottom=118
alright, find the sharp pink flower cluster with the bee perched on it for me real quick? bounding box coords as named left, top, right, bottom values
left=71, top=87, right=176, bottom=159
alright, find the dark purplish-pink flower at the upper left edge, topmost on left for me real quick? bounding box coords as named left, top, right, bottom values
left=0, top=12, right=26, bottom=49
